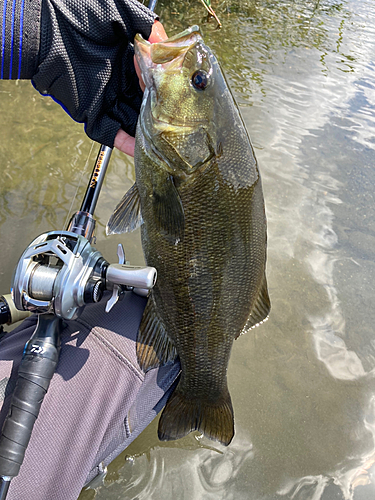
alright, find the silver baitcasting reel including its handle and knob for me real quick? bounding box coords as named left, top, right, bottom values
left=11, top=231, right=157, bottom=320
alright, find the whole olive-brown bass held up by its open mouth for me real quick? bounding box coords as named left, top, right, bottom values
left=107, top=26, right=270, bottom=445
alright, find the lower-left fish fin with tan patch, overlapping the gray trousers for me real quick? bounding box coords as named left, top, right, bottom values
left=137, top=295, right=177, bottom=372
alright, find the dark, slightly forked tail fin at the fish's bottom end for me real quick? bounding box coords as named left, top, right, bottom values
left=158, top=386, right=234, bottom=446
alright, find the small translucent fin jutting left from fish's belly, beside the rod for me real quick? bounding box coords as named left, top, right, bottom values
left=106, top=184, right=143, bottom=235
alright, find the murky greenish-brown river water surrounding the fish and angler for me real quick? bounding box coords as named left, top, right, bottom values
left=0, top=0, right=375, bottom=500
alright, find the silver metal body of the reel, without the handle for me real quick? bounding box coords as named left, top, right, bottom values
left=12, top=231, right=103, bottom=319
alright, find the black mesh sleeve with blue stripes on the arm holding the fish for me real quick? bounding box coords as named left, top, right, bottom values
left=0, top=0, right=157, bottom=147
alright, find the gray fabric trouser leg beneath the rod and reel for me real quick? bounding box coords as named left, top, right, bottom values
left=0, top=293, right=179, bottom=500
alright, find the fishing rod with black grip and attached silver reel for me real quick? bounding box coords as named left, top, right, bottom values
left=0, top=0, right=157, bottom=494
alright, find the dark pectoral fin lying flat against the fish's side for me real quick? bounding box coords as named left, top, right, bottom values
left=152, top=175, right=185, bottom=240
